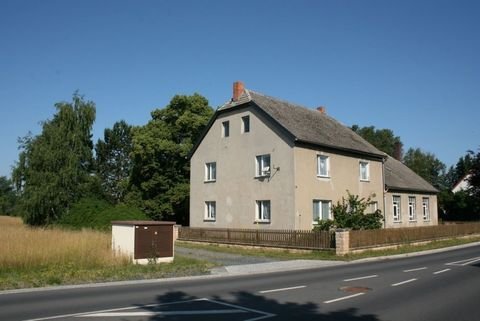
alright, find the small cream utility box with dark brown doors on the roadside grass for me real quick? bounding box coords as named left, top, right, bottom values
left=112, top=221, right=175, bottom=264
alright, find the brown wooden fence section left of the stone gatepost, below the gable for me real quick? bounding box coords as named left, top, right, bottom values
left=178, top=227, right=335, bottom=250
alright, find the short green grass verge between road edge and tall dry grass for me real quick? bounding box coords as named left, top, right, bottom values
left=0, top=256, right=214, bottom=290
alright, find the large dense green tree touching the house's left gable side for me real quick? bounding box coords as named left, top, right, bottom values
left=126, top=94, right=213, bottom=224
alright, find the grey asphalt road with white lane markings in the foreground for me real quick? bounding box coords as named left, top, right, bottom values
left=0, top=245, right=480, bottom=321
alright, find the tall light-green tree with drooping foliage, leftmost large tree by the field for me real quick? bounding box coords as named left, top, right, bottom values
left=12, top=93, right=95, bottom=225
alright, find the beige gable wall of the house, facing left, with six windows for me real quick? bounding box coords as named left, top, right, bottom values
left=190, top=107, right=295, bottom=229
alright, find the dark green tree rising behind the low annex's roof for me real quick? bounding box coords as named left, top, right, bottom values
left=403, top=148, right=446, bottom=189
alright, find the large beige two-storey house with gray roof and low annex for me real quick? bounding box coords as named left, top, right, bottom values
left=190, top=82, right=437, bottom=230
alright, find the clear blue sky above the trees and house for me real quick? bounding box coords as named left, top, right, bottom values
left=0, top=0, right=480, bottom=176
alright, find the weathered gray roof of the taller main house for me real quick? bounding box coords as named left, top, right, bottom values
left=219, top=90, right=386, bottom=158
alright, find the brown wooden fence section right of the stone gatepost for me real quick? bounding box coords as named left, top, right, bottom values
left=350, top=223, right=480, bottom=249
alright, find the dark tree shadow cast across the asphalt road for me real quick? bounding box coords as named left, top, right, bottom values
left=141, top=292, right=380, bottom=321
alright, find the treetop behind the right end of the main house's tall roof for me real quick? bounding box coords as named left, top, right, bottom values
left=352, top=125, right=403, bottom=160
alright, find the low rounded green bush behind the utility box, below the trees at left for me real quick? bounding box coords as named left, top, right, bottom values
left=57, top=198, right=149, bottom=230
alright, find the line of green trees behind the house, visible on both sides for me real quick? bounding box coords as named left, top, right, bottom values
left=0, top=92, right=480, bottom=227
